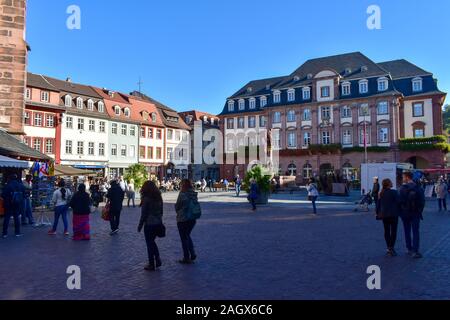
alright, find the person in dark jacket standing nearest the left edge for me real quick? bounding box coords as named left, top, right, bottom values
left=2, top=174, right=25, bottom=238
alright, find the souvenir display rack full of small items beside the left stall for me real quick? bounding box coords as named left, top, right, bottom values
left=30, top=162, right=56, bottom=227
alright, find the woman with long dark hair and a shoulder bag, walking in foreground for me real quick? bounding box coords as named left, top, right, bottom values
left=138, top=181, right=165, bottom=271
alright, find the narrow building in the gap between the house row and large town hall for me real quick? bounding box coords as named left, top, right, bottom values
left=180, top=110, right=220, bottom=181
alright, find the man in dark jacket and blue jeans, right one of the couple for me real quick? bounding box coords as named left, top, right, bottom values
left=400, top=172, right=425, bottom=259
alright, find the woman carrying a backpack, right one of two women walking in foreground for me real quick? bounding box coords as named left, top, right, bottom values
left=175, top=179, right=201, bottom=264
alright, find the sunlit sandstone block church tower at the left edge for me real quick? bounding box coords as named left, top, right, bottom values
left=0, top=0, right=28, bottom=135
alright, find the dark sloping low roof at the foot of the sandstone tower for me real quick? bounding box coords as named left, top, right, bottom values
left=0, top=130, right=51, bottom=160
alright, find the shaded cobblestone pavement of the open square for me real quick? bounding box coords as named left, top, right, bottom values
left=0, top=193, right=450, bottom=300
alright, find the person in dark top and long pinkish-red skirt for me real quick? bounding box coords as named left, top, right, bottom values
left=69, top=184, right=92, bottom=241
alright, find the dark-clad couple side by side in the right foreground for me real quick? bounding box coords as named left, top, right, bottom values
left=374, top=172, right=425, bottom=259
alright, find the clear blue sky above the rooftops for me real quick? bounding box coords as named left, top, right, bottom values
left=27, top=0, right=450, bottom=113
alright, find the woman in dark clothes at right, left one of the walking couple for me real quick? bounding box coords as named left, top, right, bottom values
left=377, top=179, right=400, bottom=257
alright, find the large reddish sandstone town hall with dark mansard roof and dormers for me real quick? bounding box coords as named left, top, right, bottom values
left=220, top=52, right=446, bottom=181
